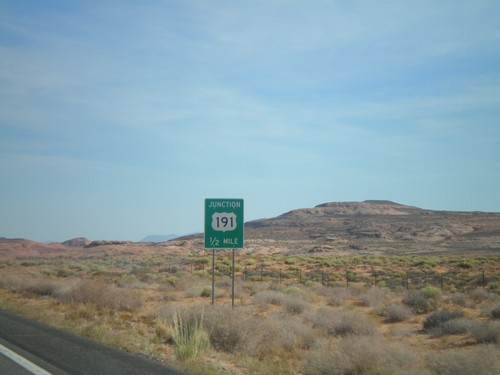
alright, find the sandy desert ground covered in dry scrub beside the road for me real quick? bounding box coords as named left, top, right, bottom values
left=0, top=251, right=500, bottom=375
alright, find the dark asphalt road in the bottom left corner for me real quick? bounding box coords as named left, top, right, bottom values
left=0, top=311, right=186, bottom=375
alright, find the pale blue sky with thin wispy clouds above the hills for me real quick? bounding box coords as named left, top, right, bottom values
left=0, top=0, right=500, bottom=241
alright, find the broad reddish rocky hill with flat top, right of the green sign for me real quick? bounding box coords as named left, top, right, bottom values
left=245, top=201, right=500, bottom=254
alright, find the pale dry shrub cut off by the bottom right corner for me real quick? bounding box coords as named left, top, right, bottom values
left=428, top=346, right=500, bottom=375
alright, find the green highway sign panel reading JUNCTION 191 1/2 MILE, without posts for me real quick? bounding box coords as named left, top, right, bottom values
left=205, top=198, right=244, bottom=249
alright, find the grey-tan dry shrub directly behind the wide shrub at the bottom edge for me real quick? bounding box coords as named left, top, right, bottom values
left=312, top=307, right=377, bottom=336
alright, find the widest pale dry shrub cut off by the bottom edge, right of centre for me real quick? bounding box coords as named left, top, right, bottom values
left=304, top=336, right=422, bottom=375
